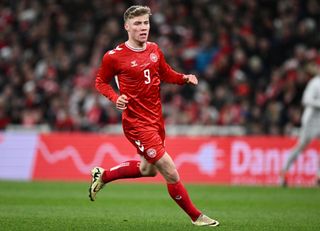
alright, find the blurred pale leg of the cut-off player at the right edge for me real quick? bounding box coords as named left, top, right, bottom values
left=280, top=132, right=310, bottom=187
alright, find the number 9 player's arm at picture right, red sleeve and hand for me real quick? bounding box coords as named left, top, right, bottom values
left=158, top=48, right=198, bottom=85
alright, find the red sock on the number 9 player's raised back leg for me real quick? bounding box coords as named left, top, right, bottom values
left=102, top=160, right=142, bottom=183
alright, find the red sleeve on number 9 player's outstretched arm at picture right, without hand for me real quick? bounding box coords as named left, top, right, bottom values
left=158, top=47, right=185, bottom=85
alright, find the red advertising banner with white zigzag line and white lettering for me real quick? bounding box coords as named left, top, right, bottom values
left=33, top=133, right=320, bottom=186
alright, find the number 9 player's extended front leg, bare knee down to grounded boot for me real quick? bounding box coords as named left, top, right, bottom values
left=155, top=153, right=219, bottom=226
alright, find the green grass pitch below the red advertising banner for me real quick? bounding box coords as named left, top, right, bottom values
left=0, top=181, right=320, bottom=231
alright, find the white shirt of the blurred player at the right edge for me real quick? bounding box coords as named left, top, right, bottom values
left=302, top=77, right=320, bottom=108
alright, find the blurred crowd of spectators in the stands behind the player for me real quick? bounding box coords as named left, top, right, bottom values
left=0, top=0, right=320, bottom=135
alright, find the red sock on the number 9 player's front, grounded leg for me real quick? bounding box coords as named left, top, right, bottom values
left=167, top=181, right=201, bottom=221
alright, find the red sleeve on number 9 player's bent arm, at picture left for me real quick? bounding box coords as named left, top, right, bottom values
left=95, top=53, right=119, bottom=103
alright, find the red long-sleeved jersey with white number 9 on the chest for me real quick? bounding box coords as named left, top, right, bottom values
left=96, top=42, right=185, bottom=128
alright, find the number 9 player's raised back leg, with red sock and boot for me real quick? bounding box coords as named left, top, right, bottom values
left=89, top=157, right=157, bottom=201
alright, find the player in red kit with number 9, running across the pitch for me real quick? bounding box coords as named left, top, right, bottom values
left=89, top=5, right=219, bottom=226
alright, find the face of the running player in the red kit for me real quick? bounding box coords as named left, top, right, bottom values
left=125, top=14, right=150, bottom=45
